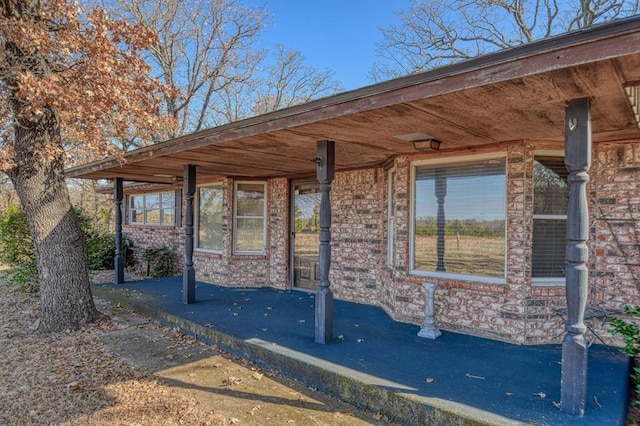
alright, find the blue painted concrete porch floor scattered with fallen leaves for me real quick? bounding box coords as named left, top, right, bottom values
left=93, top=277, right=630, bottom=425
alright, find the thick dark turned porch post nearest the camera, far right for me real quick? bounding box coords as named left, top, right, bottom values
left=561, top=98, right=591, bottom=416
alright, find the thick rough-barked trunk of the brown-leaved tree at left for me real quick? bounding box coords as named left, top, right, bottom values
left=9, top=105, right=102, bottom=333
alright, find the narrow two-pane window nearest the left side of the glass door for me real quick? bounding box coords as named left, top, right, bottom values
left=233, top=182, right=267, bottom=253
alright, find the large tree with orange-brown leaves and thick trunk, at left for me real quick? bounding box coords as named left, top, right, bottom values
left=0, top=0, right=170, bottom=332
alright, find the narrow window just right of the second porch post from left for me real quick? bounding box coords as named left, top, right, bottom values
left=196, top=185, right=222, bottom=251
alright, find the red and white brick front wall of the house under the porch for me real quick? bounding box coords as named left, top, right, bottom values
left=125, top=138, right=640, bottom=344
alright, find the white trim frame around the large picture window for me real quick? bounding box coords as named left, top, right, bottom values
left=409, top=152, right=509, bottom=284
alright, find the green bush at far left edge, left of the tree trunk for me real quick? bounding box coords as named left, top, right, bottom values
left=0, top=204, right=38, bottom=292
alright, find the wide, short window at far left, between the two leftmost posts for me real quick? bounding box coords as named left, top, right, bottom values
left=129, top=191, right=176, bottom=225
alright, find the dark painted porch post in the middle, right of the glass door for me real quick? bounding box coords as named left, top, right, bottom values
left=315, top=141, right=335, bottom=344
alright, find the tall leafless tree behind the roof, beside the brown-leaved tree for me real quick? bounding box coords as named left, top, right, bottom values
left=109, top=0, right=269, bottom=137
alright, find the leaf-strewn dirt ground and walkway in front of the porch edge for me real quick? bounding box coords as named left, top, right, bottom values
left=0, top=272, right=389, bottom=426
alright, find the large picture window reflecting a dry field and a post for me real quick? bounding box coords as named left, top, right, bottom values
left=411, top=158, right=506, bottom=283
